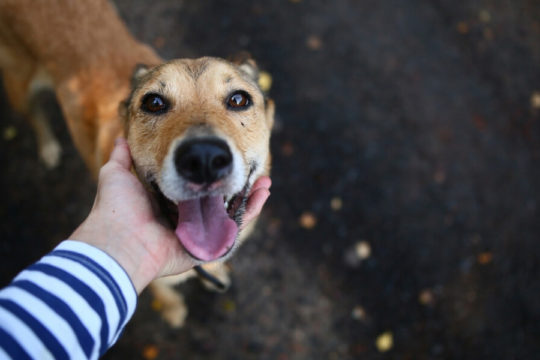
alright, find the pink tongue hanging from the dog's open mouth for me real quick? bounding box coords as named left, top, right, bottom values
left=175, top=196, right=238, bottom=261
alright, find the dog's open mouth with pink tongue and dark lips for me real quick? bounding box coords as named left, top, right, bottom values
left=151, top=168, right=254, bottom=262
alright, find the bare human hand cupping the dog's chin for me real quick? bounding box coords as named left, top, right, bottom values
left=70, top=139, right=271, bottom=293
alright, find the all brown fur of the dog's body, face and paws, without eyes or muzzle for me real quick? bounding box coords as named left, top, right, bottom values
left=0, top=0, right=274, bottom=326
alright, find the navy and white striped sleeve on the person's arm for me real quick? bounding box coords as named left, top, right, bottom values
left=0, top=240, right=137, bottom=359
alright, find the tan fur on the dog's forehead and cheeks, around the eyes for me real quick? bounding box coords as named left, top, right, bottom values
left=127, top=58, right=273, bottom=180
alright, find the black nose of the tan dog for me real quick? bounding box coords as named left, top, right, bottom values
left=175, top=139, right=232, bottom=185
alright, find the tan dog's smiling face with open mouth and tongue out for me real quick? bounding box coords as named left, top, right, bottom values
left=123, top=58, right=274, bottom=262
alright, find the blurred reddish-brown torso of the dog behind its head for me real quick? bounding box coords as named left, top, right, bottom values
left=0, top=0, right=162, bottom=171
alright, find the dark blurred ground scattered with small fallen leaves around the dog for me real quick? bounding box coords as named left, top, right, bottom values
left=0, top=0, right=540, bottom=359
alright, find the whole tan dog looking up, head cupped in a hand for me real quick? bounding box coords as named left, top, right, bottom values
left=0, top=0, right=274, bottom=327
